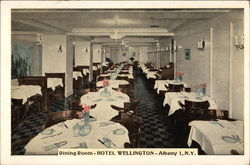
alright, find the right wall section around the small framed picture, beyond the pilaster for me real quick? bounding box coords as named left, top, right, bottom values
left=176, top=21, right=210, bottom=94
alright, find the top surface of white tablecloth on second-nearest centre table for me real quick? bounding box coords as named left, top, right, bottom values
left=81, top=87, right=130, bottom=107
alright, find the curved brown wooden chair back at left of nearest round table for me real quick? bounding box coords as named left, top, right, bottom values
left=45, top=110, right=77, bottom=128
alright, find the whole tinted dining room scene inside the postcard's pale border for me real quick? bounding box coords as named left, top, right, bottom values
left=3, top=2, right=249, bottom=162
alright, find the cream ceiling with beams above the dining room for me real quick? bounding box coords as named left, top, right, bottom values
left=11, top=9, right=229, bottom=45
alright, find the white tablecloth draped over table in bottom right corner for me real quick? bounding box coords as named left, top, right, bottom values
left=188, top=120, right=244, bottom=155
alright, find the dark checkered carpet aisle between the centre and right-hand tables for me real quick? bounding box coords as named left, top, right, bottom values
left=135, top=67, right=180, bottom=148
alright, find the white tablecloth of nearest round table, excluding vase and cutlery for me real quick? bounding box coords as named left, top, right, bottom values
left=25, top=119, right=129, bottom=155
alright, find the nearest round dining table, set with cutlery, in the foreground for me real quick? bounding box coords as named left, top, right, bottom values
left=24, top=118, right=129, bottom=155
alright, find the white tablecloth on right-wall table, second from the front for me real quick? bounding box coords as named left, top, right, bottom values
left=163, top=92, right=217, bottom=115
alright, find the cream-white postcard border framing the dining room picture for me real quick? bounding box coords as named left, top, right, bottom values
left=1, top=1, right=250, bottom=165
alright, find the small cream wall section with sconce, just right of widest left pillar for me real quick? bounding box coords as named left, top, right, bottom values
left=75, top=41, right=90, bottom=66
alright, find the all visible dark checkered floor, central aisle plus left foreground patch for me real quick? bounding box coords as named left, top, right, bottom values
left=11, top=66, right=186, bottom=155
